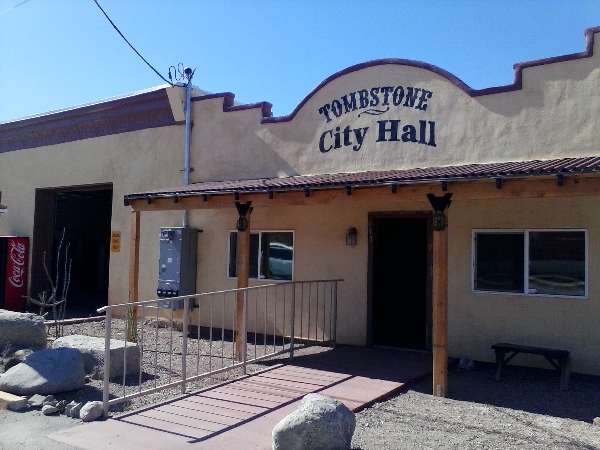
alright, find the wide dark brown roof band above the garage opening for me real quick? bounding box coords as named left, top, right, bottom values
left=0, top=88, right=177, bottom=153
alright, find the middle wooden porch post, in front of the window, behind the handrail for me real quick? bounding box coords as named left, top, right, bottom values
left=235, top=202, right=252, bottom=361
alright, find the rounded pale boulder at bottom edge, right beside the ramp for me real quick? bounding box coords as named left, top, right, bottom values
left=273, top=394, right=356, bottom=450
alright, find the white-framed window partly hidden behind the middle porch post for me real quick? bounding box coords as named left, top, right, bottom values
left=227, top=230, right=294, bottom=281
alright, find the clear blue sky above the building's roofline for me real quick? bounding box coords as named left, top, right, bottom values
left=0, top=0, right=600, bottom=121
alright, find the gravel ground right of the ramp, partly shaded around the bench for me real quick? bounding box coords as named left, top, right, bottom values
left=353, top=363, right=600, bottom=450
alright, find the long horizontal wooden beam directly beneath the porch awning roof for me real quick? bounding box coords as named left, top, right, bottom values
left=130, top=175, right=600, bottom=211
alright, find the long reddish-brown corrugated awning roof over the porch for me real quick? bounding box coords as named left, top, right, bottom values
left=125, top=156, right=600, bottom=204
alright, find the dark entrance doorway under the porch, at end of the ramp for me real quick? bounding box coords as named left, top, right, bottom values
left=369, top=214, right=431, bottom=350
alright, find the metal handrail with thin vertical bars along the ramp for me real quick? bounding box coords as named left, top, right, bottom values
left=98, top=279, right=343, bottom=412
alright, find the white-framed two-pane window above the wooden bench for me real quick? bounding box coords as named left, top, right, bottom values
left=472, top=229, right=588, bottom=298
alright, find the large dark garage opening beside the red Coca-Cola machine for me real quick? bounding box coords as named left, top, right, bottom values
left=31, top=185, right=112, bottom=317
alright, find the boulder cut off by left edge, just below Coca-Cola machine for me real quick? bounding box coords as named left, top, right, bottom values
left=0, top=309, right=46, bottom=351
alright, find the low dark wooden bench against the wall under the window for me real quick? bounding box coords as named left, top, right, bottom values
left=492, top=343, right=571, bottom=390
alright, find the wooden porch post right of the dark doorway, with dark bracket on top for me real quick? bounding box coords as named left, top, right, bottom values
left=427, top=193, right=452, bottom=397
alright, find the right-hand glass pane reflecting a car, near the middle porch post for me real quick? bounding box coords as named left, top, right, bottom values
left=260, top=232, right=294, bottom=280
